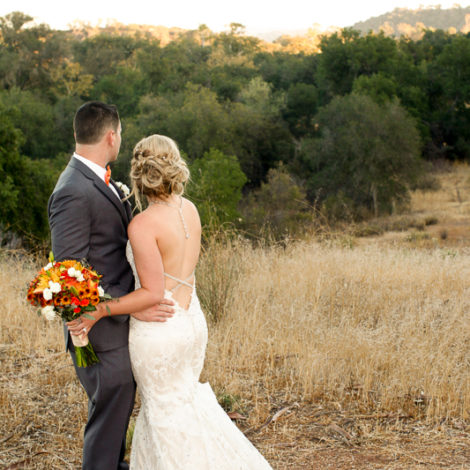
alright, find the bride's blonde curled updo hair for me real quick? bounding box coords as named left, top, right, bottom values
left=130, top=134, right=189, bottom=210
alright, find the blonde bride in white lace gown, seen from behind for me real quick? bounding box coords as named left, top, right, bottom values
left=69, top=135, right=271, bottom=470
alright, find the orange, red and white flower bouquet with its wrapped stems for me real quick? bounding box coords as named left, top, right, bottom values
left=27, top=253, right=111, bottom=367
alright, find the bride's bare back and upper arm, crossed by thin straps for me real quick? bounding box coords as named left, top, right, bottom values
left=129, top=196, right=201, bottom=309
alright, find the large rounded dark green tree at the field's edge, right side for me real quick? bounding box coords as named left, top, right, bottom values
left=297, top=94, right=422, bottom=215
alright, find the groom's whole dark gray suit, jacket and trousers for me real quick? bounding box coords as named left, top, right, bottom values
left=48, top=158, right=135, bottom=470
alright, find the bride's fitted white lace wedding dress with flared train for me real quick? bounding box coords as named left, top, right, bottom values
left=127, top=244, right=271, bottom=470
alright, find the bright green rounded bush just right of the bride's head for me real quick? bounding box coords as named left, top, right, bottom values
left=187, top=149, right=246, bottom=227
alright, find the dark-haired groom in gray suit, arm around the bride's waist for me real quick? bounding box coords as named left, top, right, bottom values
left=48, top=101, right=172, bottom=470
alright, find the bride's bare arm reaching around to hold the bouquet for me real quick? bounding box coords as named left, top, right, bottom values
left=67, top=214, right=171, bottom=335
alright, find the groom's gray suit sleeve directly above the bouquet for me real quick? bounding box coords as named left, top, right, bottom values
left=49, top=186, right=91, bottom=261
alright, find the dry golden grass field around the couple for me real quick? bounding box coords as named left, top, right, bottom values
left=0, top=166, right=470, bottom=470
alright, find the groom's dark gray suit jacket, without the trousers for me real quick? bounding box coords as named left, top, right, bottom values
left=48, top=157, right=134, bottom=352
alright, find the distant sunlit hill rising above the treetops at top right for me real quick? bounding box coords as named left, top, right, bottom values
left=352, top=6, right=470, bottom=38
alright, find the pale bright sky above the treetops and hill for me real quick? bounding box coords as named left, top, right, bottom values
left=0, top=0, right=470, bottom=32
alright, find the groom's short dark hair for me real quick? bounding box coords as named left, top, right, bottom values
left=73, top=101, right=119, bottom=144
